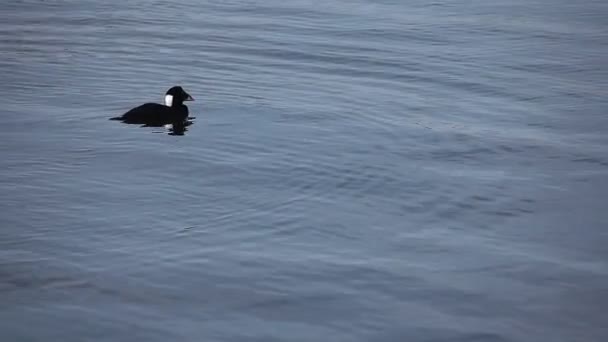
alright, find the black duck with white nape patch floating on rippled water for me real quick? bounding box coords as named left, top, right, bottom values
left=113, top=86, right=194, bottom=126
